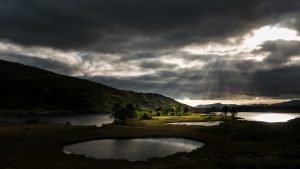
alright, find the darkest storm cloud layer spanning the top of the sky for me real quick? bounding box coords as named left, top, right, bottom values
left=0, top=0, right=299, bottom=52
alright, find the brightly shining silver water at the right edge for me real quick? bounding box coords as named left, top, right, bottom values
left=237, top=112, right=300, bottom=123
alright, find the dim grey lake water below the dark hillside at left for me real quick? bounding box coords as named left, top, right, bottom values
left=0, top=114, right=113, bottom=127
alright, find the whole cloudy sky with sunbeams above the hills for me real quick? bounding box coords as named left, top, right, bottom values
left=0, top=0, right=300, bottom=105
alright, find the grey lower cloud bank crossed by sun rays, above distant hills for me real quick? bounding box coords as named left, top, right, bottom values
left=88, top=58, right=300, bottom=100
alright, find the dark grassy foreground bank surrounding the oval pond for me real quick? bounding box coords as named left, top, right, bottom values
left=0, top=119, right=300, bottom=169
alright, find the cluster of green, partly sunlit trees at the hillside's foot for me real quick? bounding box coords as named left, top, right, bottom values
left=112, top=103, right=189, bottom=123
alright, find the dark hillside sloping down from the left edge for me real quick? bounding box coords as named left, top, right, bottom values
left=0, top=60, right=191, bottom=114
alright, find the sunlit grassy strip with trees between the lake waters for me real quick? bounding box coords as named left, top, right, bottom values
left=112, top=103, right=238, bottom=125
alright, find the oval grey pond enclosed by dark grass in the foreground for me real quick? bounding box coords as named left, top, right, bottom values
left=63, top=138, right=204, bottom=161
